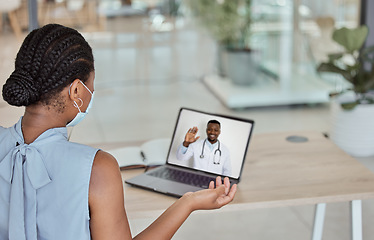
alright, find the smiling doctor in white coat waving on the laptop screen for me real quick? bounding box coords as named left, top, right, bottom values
left=177, top=120, right=231, bottom=176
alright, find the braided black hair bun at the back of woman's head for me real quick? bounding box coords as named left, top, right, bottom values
left=3, top=69, right=40, bottom=106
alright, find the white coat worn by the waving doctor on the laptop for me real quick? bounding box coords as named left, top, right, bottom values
left=177, top=139, right=231, bottom=176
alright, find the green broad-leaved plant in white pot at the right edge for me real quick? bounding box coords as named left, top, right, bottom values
left=317, top=25, right=374, bottom=157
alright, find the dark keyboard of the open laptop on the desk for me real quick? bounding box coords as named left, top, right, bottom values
left=148, top=168, right=215, bottom=188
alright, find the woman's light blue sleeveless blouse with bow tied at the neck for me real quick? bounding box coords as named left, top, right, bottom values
left=0, top=118, right=98, bottom=240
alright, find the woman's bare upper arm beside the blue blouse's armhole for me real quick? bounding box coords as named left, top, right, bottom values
left=88, top=151, right=131, bottom=240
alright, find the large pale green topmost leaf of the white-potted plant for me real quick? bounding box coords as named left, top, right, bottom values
left=332, top=25, right=369, bottom=52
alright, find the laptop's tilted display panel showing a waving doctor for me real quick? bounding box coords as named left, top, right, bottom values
left=167, top=108, right=254, bottom=179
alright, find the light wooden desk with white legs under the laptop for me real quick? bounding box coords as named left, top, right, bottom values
left=117, top=132, right=374, bottom=240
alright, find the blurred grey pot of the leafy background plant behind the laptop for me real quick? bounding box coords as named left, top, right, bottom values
left=217, top=46, right=260, bottom=85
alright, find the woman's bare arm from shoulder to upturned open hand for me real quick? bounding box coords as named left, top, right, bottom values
left=89, top=151, right=236, bottom=240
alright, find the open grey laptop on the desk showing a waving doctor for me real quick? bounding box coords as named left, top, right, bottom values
left=125, top=108, right=254, bottom=197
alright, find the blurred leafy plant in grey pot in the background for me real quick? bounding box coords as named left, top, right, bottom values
left=185, top=0, right=258, bottom=84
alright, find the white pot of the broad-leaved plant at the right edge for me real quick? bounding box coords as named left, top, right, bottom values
left=330, top=95, right=374, bottom=157
